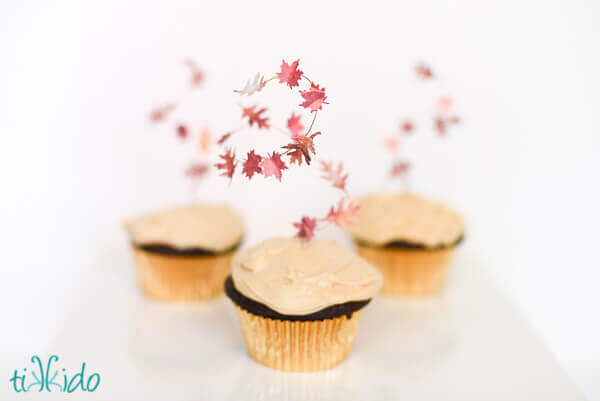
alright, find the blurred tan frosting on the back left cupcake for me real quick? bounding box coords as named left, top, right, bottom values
left=124, top=204, right=244, bottom=252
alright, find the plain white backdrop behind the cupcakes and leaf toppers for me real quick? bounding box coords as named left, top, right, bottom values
left=0, top=1, right=600, bottom=400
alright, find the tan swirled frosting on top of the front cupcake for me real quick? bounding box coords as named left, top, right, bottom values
left=232, top=238, right=383, bottom=315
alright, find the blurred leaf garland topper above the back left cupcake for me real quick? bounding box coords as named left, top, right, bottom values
left=150, top=58, right=213, bottom=196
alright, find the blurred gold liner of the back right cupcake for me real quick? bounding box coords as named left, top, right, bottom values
left=356, top=244, right=454, bottom=295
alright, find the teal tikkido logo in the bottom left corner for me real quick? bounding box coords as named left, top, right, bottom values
left=9, top=355, right=100, bottom=393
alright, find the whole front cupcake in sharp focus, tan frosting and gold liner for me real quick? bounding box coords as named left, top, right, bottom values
left=225, top=238, right=382, bottom=372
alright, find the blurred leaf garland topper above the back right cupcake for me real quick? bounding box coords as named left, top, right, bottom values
left=383, top=62, right=460, bottom=187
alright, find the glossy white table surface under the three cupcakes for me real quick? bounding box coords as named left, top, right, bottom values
left=0, top=248, right=583, bottom=401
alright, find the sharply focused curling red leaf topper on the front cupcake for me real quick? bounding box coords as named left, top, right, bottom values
left=215, top=60, right=358, bottom=240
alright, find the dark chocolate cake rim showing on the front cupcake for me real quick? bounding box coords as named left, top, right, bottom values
left=225, top=276, right=371, bottom=322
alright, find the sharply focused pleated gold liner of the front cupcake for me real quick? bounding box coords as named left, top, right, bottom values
left=234, top=304, right=361, bottom=372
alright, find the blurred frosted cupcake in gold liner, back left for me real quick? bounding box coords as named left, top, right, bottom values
left=124, top=204, right=244, bottom=301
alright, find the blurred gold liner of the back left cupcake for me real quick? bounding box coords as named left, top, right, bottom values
left=133, top=247, right=234, bottom=302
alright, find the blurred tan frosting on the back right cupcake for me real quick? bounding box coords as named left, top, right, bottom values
left=348, top=193, right=464, bottom=248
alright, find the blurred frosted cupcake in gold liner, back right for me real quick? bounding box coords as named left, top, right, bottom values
left=348, top=193, right=464, bottom=295
